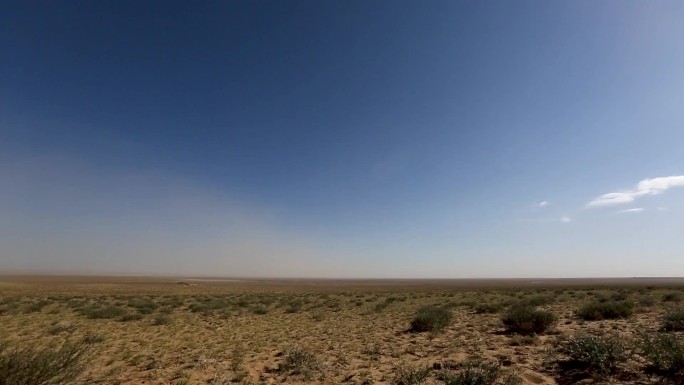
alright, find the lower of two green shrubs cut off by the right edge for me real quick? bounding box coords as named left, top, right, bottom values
left=640, top=333, right=684, bottom=378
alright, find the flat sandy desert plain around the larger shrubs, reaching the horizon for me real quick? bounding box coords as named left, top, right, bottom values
left=0, top=276, right=684, bottom=385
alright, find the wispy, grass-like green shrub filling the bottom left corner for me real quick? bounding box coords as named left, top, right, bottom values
left=0, top=342, right=87, bottom=385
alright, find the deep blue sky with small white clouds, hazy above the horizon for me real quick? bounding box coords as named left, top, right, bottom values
left=0, top=0, right=684, bottom=278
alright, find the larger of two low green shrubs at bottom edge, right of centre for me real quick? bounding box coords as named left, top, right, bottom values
left=440, top=361, right=522, bottom=385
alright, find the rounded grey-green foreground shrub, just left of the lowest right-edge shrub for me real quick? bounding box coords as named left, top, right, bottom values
left=560, top=336, right=629, bottom=375
